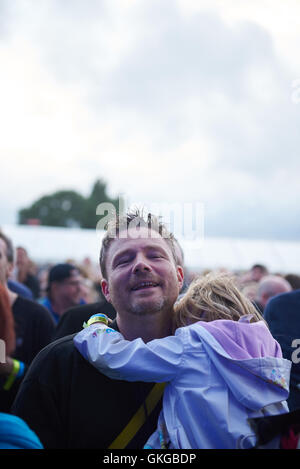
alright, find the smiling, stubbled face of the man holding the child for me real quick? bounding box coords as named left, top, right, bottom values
left=102, top=228, right=183, bottom=315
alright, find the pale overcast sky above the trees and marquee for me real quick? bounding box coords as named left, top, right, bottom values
left=0, top=0, right=300, bottom=239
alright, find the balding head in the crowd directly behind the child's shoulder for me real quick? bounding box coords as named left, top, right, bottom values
left=255, top=275, right=292, bottom=312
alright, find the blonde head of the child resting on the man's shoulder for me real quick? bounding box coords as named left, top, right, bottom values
left=174, top=273, right=263, bottom=327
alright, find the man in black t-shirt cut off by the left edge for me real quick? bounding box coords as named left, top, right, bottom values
left=0, top=233, right=55, bottom=412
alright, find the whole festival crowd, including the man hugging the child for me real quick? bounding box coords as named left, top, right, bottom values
left=0, top=213, right=300, bottom=449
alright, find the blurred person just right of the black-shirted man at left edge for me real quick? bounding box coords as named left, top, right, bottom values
left=16, top=246, right=40, bottom=299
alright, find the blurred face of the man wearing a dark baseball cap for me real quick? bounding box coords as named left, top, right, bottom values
left=52, top=270, right=82, bottom=307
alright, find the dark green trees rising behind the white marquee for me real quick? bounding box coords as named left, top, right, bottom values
left=18, top=180, right=118, bottom=228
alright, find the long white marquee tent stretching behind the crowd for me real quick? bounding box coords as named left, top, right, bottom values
left=1, top=225, right=300, bottom=274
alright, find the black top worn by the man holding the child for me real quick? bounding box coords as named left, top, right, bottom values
left=13, top=323, right=161, bottom=449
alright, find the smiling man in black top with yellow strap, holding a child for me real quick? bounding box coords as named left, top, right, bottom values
left=13, top=212, right=183, bottom=449
